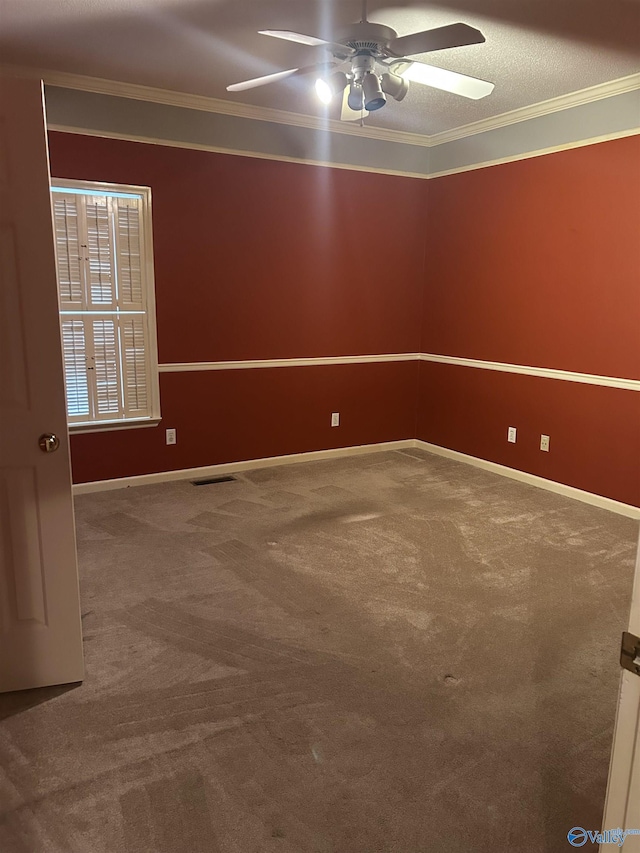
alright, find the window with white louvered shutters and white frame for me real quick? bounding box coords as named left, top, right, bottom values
left=51, top=179, right=160, bottom=430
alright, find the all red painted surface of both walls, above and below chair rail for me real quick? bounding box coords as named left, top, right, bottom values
left=50, top=133, right=640, bottom=505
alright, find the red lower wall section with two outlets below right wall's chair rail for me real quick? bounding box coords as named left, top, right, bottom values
left=418, top=362, right=640, bottom=506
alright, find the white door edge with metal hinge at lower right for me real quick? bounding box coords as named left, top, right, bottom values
left=601, top=528, right=640, bottom=853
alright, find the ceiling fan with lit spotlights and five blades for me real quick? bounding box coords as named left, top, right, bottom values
left=227, top=0, right=494, bottom=121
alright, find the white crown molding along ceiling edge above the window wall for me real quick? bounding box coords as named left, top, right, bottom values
left=0, top=66, right=429, bottom=148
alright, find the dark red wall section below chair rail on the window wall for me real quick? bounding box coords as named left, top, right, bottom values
left=71, top=362, right=418, bottom=482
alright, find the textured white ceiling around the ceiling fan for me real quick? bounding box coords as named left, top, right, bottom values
left=0, top=0, right=640, bottom=135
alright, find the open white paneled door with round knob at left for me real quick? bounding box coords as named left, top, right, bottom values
left=0, top=77, right=83, bottom=691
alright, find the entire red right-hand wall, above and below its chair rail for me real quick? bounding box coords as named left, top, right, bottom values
left=418, top=137, right=640, bottom=505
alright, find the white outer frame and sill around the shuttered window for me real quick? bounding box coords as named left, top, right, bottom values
left=49, top=177, right=162, bottom=434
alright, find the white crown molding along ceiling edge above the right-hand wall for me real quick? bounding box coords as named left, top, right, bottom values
left=428, top=73, right=640, bottom=148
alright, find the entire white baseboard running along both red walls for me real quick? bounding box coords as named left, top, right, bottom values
left=73, top=438, right=640, bottom=520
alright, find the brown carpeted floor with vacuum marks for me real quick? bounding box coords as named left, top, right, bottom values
left=0, top=450, right=637, bottom=853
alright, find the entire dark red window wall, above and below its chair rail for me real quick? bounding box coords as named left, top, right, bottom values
left=50, top=132, right=426, bottom=482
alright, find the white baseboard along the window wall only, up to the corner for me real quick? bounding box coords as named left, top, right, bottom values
left=73, top=438, right=416, bottom=495
